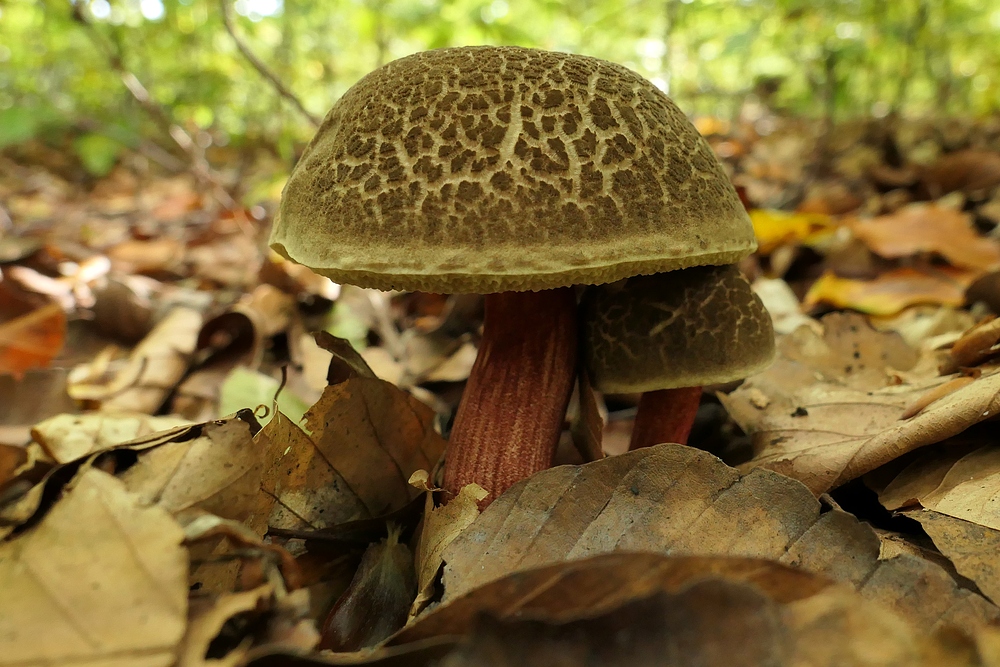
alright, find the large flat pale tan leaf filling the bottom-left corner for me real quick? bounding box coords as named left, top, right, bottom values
left=0, top=469, right=187, bottom=667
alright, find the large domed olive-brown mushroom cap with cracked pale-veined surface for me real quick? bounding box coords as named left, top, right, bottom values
left=271, top=47, right=755, bottom=293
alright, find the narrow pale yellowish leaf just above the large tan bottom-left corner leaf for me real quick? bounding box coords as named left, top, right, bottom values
left=31, top=412, right=190, bottom=463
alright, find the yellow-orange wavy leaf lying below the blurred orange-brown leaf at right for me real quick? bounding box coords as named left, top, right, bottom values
left=802, top=267, right=979, bottom=316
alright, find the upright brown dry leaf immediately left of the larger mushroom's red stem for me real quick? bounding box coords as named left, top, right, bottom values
left=304, top=377, right=446, bottom=516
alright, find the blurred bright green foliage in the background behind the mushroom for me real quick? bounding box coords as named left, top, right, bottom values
left=0, top=0, right=1000, bottom=166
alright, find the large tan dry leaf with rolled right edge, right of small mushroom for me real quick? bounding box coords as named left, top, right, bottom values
left=719, top=316, right=1000, bottom=494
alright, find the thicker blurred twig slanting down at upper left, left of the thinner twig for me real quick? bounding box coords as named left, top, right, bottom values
left=73, top=3, right=236, bottom=209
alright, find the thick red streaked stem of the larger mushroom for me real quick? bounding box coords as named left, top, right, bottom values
left=444, top=287, right=577, bottom=507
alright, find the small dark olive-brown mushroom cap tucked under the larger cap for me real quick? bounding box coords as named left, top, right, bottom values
left=581, top=266, right=774, bottom=394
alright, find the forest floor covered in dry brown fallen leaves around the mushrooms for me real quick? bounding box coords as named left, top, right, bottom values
left=0, top=115, right=1000, bottom=667
